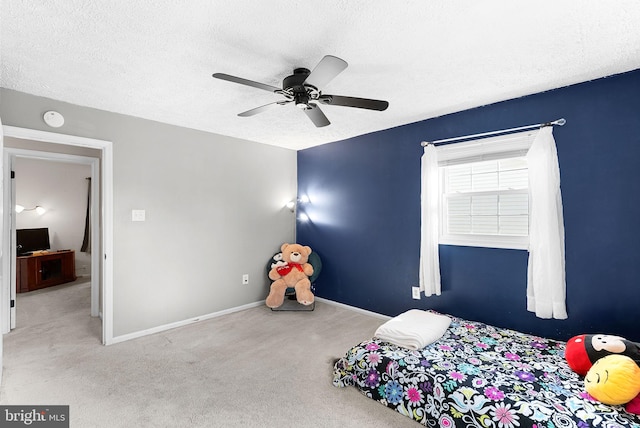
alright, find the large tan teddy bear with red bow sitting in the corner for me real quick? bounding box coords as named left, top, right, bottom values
left=265, top=243, right=314, bottom=308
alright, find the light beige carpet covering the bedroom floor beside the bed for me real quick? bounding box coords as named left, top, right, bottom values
left=0, top=283, right=418, bottom=428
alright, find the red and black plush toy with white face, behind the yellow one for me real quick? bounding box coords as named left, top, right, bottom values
left=565, top=334, right=640, bottom=376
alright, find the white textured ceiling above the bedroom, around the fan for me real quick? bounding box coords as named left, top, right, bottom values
left=0, top=0, right=640, bottom=149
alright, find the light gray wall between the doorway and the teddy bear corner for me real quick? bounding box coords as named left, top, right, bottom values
left=0, top=89, right=296, bottom=337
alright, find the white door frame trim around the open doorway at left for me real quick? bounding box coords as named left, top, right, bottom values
left=0, top=126, right=113, bottom=345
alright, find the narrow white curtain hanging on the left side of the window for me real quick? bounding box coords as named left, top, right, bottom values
left=420, top=144, right=440, bottom=297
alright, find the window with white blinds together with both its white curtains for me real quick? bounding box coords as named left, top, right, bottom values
left=419, top=126, right=567, bottom=319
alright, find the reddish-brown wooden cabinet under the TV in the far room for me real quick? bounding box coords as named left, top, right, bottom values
left=16, top=250, right=76, bottom=293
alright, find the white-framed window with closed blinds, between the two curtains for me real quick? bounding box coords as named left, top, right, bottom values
left=438, top=132, right=535, bottom=249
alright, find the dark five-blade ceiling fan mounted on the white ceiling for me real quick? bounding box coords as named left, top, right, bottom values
left=213, top=55, right=389, bottom=127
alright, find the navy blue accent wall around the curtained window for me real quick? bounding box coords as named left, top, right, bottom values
left=297, top=70, right=640, bottom=341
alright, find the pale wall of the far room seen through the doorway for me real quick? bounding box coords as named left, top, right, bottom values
left=13, top=157, right=91, bottom=276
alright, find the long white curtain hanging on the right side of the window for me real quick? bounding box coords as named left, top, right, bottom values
left=527, top=126, right=567, bottom=319
